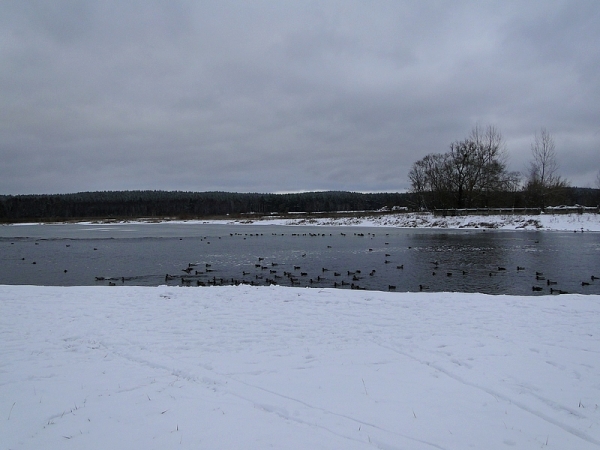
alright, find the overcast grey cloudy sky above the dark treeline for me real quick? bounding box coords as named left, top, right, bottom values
left=0, top=0, right=600, bottom=194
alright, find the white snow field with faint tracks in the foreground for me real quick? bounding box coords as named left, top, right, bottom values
left=0, top=286, right=600, bottom=450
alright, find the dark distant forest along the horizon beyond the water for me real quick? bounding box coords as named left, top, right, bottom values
left=0, top=188, right=600, bottom=223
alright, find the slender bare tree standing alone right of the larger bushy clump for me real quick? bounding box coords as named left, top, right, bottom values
left=525, top=128, right=568, bottom=208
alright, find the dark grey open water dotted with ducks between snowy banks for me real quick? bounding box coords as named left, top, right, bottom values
left=0, top=223, right=600, bottom=295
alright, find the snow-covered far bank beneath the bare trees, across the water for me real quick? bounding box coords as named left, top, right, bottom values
left=236, top=213, right=600, bottom=231
